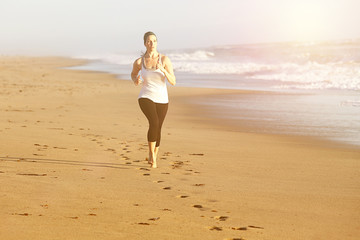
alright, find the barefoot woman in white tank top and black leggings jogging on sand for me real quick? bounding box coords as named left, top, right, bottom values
left=131, top=32, right=176, bottom=168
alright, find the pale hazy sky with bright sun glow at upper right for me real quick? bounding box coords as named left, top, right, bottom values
left=0, top=0, right=360, bottom=55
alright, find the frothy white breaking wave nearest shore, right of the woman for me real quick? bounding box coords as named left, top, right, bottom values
left=174, top=62, right=360, bottom=90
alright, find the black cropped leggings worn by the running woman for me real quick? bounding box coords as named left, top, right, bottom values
left=139, top=98, right=169, bottom=147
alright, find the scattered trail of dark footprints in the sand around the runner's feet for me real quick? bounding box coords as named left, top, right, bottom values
left=13, top=132, right=264, bottom=240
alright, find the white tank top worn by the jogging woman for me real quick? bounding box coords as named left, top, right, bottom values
left=139, top=54, right=169, bottom=103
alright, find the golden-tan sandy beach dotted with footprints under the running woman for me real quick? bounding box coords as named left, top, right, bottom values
left=0, top=57, right=360, bottom=240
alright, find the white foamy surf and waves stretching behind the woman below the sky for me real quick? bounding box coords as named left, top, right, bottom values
left=74, top=40, right=360, bottom=90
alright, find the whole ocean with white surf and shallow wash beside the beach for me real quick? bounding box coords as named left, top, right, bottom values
left=73, top=39, right=360, bottom=147
